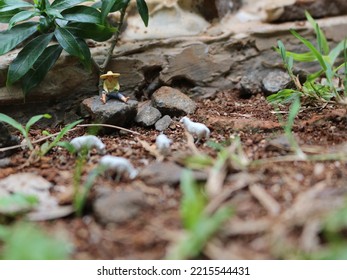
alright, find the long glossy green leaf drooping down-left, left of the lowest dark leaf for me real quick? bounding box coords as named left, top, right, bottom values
left=7, top=33, right=53, bottom=85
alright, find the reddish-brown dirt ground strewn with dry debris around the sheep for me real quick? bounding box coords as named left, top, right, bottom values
left=0, top=92, right=347, bottom=259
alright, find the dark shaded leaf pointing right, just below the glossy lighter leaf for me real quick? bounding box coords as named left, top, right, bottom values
left=65, top=22, right=117, bottom=42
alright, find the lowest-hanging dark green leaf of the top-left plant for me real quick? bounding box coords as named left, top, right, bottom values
left=22, top=45, right=63, bottom=94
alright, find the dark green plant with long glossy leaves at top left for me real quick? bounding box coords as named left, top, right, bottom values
left=0, top=0, right=148, bottom=94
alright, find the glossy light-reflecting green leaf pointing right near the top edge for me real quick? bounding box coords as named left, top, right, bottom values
left=61, top=6, right=101, bottom=23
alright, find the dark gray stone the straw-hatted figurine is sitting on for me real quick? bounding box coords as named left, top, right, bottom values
left=82, top=96, right=138, bottom=131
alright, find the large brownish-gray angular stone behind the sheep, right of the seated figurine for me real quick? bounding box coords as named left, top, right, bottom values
left=152, top=86, right=196, bottom=116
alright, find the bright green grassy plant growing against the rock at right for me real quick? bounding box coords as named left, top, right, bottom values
left=268, top=12, right=347, bottom=105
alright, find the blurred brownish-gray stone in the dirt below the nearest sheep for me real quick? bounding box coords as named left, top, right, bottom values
left=93, top=190, right=146, bottom=224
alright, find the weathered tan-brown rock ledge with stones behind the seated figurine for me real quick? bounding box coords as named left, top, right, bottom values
left=0, top=0, right=347, bottom=126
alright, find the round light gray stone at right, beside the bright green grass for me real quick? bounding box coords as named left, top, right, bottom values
left=262, top=70, right=292, bottom=94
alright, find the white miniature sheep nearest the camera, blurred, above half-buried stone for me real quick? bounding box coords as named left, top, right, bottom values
left=99, top=155, right=138, bottom=181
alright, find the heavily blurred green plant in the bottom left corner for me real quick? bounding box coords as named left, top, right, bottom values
left=0, top=222, right=72, bottom=260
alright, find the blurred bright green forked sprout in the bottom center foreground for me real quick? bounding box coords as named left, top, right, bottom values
left=167, top=170, right=233, bottom=259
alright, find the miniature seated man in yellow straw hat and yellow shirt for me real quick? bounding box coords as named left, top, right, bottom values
left=100, top=71, right=129, bottom=104
